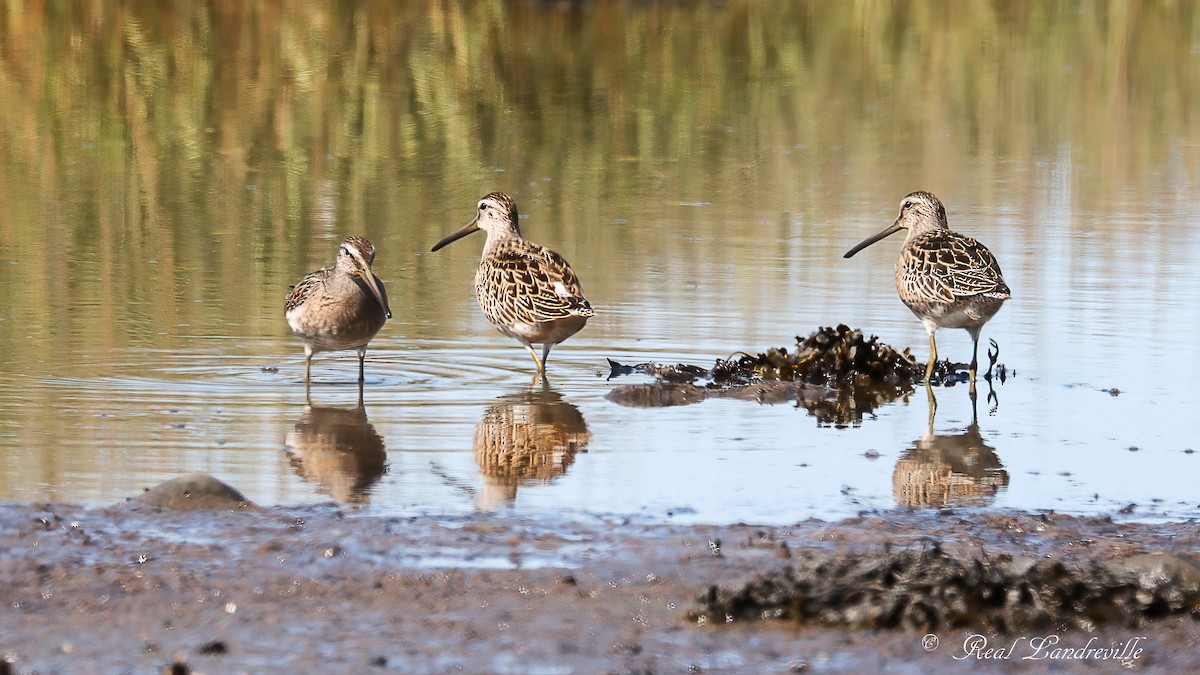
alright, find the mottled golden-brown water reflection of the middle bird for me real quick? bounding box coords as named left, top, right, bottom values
left=474, top=380, right=592, bottom=510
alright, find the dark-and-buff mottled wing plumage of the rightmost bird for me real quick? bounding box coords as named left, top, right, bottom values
left=896, top=229, right=1010, bottom=303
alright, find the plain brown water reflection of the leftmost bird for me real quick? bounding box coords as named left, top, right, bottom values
left=284, top=394, right=388, bottom=504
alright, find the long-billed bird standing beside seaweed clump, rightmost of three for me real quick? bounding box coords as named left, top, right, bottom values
left=845, top=192, right=1012, bottom=386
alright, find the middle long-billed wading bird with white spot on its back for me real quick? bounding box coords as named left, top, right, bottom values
left=433, top=192, right=593, bottom=377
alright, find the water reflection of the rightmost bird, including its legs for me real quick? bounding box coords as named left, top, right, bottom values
left=892, top=384, right=1008, bottom=508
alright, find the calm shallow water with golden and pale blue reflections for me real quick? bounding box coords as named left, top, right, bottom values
left=0, top=1, right=1200, bottom=522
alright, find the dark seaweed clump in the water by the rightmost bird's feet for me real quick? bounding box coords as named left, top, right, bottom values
left=608, top=324, right=1007, bottom=425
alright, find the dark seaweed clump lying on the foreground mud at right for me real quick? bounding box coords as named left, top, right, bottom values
left=691, top=544, right=1200, bottom=634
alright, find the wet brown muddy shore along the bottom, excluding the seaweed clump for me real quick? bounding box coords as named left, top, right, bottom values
left=0, top=485, right=1200, bottom=673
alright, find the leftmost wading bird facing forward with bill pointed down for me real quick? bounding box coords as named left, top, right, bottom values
left=283, top=237, right=391, bottom=384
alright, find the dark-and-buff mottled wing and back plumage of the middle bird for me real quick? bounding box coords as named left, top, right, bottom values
left=475, top=239, right=593, bottom=325
